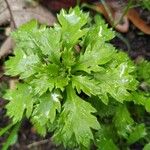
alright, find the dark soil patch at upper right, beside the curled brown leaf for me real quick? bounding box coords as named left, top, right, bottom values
left=112, top=8, right=150, bottom=60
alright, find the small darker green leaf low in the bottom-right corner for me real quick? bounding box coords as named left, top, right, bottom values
left=127, top=124, right=147, bottom=144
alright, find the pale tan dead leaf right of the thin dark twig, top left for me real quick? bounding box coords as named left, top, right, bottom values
left=4, top=0, right=55, bottom=28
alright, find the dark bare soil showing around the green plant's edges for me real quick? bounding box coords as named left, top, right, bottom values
left=0, top=3, right=150, bottom=150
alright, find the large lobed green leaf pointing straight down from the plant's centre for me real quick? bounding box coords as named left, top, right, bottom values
left=54, top=86, right=100, bottom=148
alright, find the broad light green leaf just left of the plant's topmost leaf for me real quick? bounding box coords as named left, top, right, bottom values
left=26, top=27, right=61, bottom=64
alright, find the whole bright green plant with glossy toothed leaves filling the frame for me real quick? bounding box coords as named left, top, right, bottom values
left=3, top=7, right=150, bottom=150
